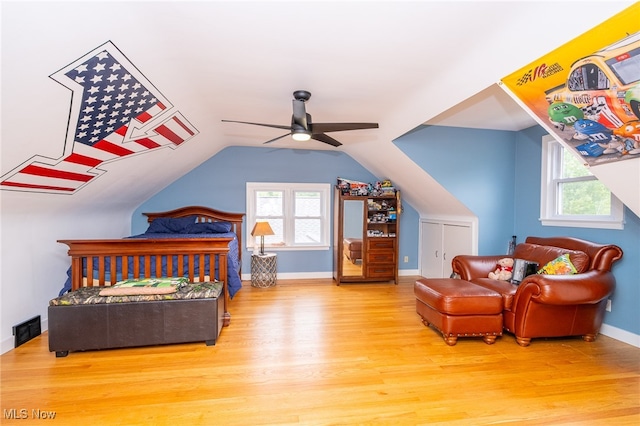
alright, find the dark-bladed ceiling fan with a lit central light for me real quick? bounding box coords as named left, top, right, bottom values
left=222, top=90, right=378, bottom=146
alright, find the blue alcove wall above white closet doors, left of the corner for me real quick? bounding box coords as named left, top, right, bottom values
left=395, top=126, right=517, bottom=254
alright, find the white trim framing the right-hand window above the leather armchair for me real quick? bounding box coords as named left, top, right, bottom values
left=540, top=135, right=624, bottom=229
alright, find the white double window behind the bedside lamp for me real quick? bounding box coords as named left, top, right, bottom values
left=246, top=182, right=331, bottom=250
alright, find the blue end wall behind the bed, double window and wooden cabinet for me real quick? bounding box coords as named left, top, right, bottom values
left=132, top=147, right=419, bottom=273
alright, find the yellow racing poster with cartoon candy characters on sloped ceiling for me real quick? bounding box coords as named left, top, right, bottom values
left=501, top=3, right=640, bottom=165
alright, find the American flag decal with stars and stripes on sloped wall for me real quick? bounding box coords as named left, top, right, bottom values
left=0, top=42, right=198, bottom=194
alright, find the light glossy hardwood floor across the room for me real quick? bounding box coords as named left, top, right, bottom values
left=0, top=277, right=640, bottom=426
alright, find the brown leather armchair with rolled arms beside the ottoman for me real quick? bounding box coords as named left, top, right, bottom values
left=452, top=237, right=622, bottom=346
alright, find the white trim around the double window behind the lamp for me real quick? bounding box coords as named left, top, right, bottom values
left=246, top=182, right=332, bottom=251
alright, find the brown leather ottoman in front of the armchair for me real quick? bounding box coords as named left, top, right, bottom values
left=414, top=278, right=503, bottom=346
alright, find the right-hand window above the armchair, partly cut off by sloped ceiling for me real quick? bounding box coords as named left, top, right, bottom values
left=540, top=135, right=624, bottom=229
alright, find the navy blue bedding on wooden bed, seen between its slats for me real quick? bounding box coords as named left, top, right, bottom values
left=59, top=227, right=242, bottom=298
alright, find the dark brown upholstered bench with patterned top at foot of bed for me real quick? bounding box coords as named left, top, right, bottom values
left=48, top=282, right=224, bottom=357
